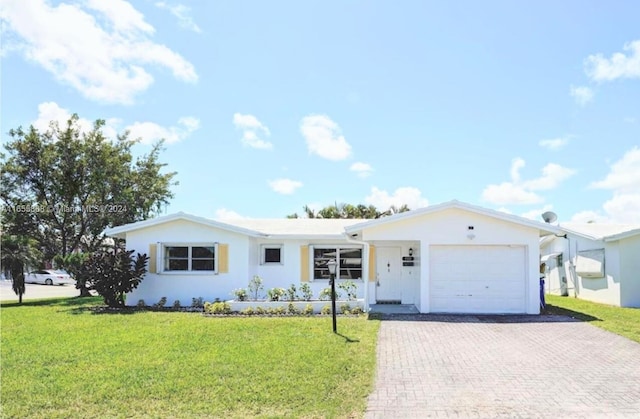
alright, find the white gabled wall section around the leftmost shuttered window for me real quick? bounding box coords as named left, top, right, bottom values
left=121, top=220, right=249, bottom=306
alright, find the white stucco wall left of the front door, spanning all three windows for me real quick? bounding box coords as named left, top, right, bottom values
left=119, top=225, right=368, bottom=306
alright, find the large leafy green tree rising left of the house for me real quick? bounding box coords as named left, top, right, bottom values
left=0, top=115, right=176, bottom=294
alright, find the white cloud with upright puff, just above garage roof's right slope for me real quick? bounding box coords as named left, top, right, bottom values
left=482, top=157, right=575, bottom=205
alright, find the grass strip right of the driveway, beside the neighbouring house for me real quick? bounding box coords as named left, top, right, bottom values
left=545, top=295, right=640, bottom=342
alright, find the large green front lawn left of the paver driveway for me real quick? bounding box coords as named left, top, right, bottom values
left=0, top=297, right=379, bottom=418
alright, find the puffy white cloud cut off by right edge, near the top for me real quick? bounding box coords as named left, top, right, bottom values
left=585, top=39, right=640, bottom=81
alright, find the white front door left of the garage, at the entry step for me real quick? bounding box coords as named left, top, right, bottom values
left=376, top=246, right=402, bottom=304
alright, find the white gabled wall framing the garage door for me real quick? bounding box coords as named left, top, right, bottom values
left=363, top=208, right=540, bottom=314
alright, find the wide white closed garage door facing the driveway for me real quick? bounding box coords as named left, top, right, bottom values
left=429, top=246, right=526, bottom=313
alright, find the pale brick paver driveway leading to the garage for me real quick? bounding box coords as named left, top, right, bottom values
left=366, top=315, right=640, bottom=418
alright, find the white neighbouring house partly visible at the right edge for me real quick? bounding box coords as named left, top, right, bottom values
left=540, top=223, right=640, bottom=307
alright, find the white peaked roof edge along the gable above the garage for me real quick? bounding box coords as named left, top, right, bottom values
left=345, top=200, right=561, bottom=236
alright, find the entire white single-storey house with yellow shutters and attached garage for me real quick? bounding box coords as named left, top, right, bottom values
left=106, top=201, right=560, bottom=314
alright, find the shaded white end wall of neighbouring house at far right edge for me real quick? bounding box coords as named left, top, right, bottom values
left=619, top=236, right=640, bottom=307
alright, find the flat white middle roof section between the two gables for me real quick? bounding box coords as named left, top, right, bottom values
left=221, top=218, right=363, bottom=238
